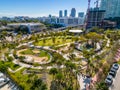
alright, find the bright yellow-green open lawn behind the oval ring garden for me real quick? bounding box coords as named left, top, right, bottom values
left=34, top=37, right=72, bottom=46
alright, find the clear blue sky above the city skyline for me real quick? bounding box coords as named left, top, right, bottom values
left=0, top=0, right=96, bottom=17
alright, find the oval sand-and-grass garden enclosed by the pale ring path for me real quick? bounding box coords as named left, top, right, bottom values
left=17, top=48, right=51, bottom=63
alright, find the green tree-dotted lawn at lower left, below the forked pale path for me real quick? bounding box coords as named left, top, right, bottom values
left=8, top=68, right=46, bottom=90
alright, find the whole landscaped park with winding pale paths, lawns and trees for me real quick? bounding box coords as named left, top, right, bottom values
left=0, top=28, right=119, bottom=90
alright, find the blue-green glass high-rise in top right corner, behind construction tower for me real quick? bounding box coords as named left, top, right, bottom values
left=100, top=0, right=120, bottom=18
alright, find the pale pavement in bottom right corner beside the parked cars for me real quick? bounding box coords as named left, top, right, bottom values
left=109, top=65, right=120, bottom=90
